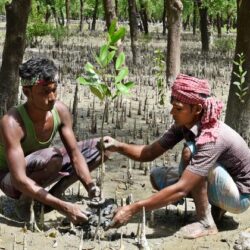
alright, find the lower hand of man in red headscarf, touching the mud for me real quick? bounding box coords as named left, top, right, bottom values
left=108, top=205, right=135, bottom=228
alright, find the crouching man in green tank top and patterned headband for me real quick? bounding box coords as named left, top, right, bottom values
left=0, top=58, right=109, bottom=224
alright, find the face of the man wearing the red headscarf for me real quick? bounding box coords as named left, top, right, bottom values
left=170, top=98, right=202, bottom=128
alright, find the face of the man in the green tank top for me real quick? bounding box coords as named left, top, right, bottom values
left=27, top=82, right=57, bottom=111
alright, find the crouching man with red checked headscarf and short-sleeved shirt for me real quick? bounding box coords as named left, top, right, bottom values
left=104, top=74, right=250, bottom=238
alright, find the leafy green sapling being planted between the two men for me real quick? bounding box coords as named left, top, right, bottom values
left=77, top=20, right=134, bottom=237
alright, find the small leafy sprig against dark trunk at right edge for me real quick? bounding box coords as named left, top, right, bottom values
left=233, top=53, right=248, bottom=103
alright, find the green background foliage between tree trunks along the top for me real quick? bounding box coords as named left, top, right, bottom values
left=0, top=0, right=236, bottom=51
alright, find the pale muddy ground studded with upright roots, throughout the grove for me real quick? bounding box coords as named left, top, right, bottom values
left=0, top=20, right=250, bottom=250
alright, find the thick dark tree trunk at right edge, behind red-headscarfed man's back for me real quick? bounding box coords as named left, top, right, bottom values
left=225, top=0, right=250, bottom=145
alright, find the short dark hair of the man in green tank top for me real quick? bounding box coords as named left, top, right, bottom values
left=19, top=58, right=58, bottom=81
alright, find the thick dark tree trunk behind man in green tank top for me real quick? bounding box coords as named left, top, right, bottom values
left=0, top=0, right=31, bottom=116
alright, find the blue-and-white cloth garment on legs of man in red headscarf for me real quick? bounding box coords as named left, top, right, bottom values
left=151, top=142, right=250, bottom=213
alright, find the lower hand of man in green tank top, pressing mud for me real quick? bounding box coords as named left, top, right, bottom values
left=66, top=203, right=88, bottom=225
